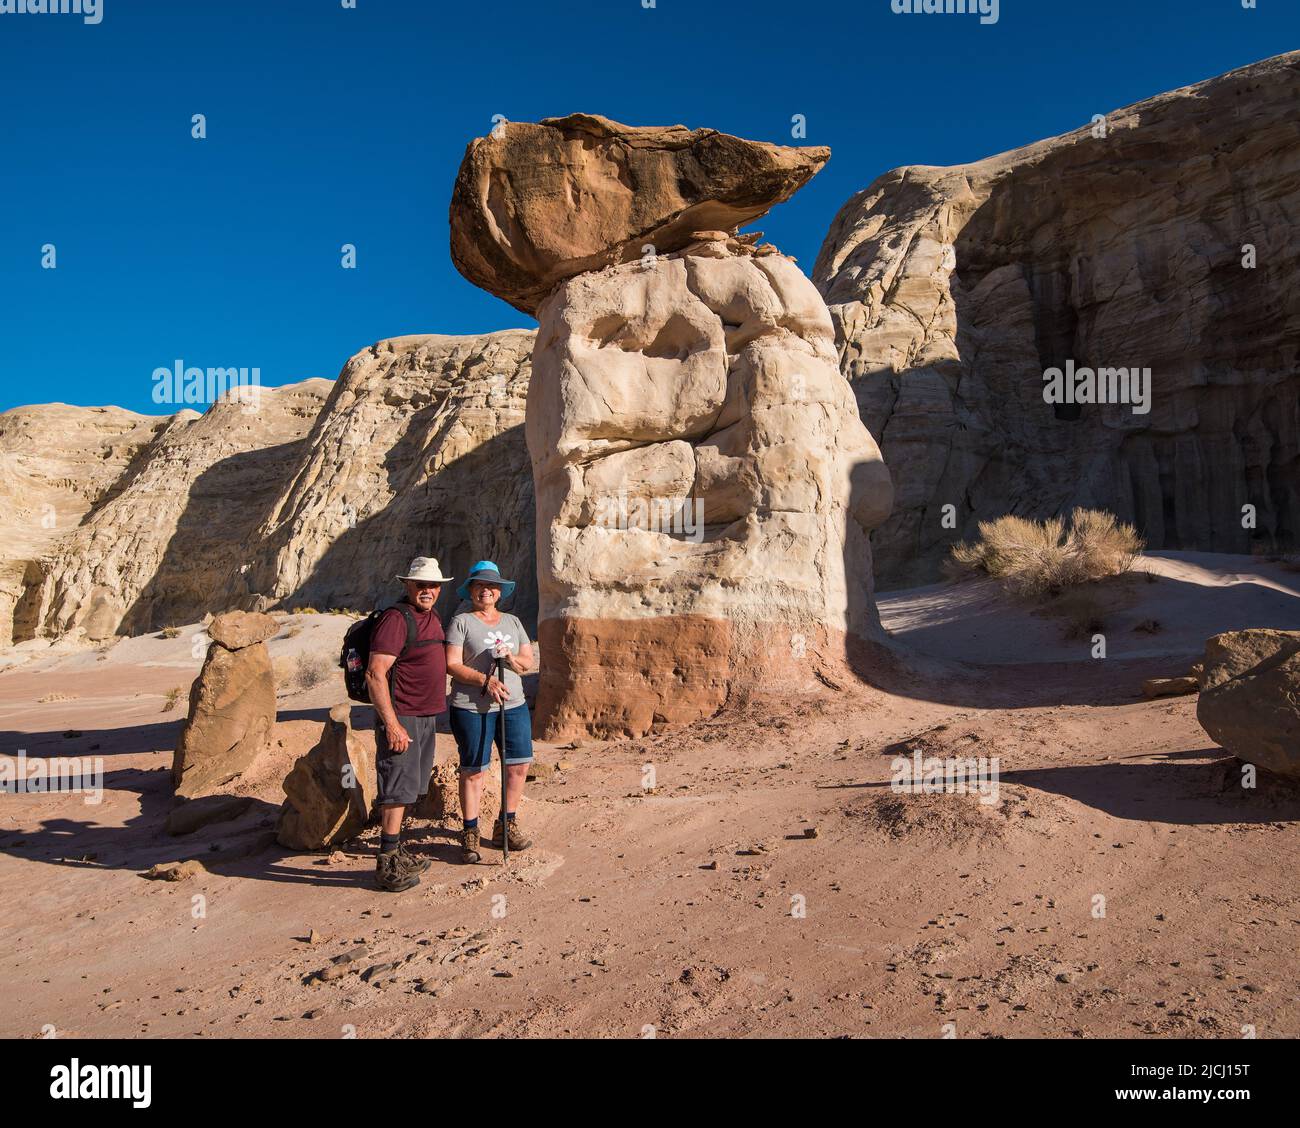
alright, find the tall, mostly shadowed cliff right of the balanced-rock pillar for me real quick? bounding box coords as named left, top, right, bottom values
left=814, top=53, right=1300, bottom=586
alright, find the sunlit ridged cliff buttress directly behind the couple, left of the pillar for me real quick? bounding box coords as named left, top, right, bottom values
left=231, top=329, right=537, bottom=624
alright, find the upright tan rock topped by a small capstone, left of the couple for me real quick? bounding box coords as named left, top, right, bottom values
left=172, top=611, right=278, bottom=799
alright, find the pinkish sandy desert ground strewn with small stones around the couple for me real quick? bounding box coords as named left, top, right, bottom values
left=0, top=554, right=1300, bottom=1038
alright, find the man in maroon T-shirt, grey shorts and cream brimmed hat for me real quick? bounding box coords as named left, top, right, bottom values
left=365, top=556, right=452, bottom=893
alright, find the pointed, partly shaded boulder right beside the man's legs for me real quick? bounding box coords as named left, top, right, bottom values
left=276, top=702, right=377, bottom=850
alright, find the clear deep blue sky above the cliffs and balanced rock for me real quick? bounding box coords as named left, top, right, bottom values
left=0, top=0, right=1300, bottom=413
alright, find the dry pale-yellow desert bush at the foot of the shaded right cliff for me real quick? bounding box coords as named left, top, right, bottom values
left=948, top=509, right=1145, bottom=595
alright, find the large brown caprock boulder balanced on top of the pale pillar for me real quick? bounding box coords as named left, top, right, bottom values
left=451, top=113, right=831, bottom=313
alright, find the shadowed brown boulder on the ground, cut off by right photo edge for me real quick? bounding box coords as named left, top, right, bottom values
left=1196, top=630, right=1300, bottom=780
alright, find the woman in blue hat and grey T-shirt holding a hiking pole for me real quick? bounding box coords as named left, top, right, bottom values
left=447, top=560, right=533, bottom=863
